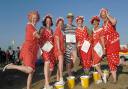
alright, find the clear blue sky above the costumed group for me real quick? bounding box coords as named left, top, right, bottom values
left=0, top=0, right=128, bottom=48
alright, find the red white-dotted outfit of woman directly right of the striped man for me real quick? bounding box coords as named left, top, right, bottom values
left=76, top=27, right=92, bottom=69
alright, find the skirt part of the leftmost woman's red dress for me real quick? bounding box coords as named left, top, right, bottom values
left=20, top=42, right=39, bottom=69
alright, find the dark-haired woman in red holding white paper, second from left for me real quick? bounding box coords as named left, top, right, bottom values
left=40, top=14, right=55, bottom=89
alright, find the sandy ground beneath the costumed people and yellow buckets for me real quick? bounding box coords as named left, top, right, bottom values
left=0, top=62, right=128, bottom=89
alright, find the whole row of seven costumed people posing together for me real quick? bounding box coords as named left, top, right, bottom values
left=3, top=8, right=120, bottom=89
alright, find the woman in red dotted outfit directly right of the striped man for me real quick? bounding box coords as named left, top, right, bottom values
left=76, top=16, right=92, bottom=74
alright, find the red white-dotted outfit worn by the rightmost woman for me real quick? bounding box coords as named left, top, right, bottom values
left=103, top=21, right=120, bottom=71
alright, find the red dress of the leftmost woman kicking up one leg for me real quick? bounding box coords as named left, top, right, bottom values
left=20, top=24, right=39, bottom=69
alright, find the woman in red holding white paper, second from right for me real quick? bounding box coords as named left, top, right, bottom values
left=90, top=16, right=106, bottom=83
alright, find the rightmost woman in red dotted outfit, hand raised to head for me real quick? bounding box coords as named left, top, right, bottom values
left=100, top=8, right=120, bottom=83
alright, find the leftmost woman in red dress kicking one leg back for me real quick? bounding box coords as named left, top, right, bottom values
left=3, top=11, right=40, bottom=89
